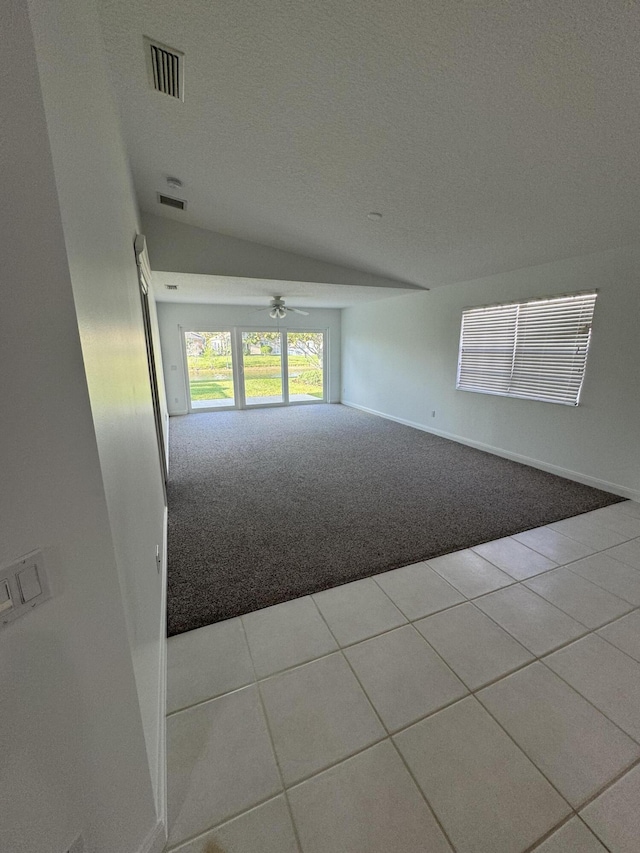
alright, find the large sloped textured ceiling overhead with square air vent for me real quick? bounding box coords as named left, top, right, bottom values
left=100, top=0, right=640, bottom=287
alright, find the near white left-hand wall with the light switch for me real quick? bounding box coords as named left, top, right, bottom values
left=0, top=0, right=168, bottom=853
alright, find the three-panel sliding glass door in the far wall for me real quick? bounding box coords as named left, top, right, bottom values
left=184, top=328, right=326, bottom=412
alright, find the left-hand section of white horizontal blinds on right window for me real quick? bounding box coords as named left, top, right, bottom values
left=457, top=305, right=518, bottom=394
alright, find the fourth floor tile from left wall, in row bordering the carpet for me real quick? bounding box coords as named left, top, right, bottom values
left=375, top=563, right=464, bottom=619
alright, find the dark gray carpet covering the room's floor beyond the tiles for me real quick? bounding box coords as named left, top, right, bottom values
left=168, top=405, right=621, bottom=636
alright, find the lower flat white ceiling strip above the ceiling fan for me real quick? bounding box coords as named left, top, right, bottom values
left=153, top=271, right=416, bottom=308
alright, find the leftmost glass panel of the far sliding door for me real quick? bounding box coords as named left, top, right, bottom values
left=184, top=332, right=236, bottom=411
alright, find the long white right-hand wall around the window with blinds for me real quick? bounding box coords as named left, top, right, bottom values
left=342, top=248, right=640, bottom=499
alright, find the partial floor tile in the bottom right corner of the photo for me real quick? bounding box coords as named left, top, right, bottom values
left=580, top=767, right=640, bottom=853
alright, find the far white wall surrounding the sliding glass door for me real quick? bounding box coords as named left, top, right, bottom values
left=157, top=304, right=341, bottom=415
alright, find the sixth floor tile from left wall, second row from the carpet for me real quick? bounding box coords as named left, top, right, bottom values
left=525, top=568, right=633, bottom=629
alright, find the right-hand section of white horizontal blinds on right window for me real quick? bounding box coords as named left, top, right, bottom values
left=509, top=293, right=596, bottom=406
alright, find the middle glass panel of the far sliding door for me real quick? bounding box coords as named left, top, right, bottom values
left=242, top=332, right=284, bottom=406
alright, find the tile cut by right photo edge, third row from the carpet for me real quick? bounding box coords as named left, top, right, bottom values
left=544, top=634, right=640, bottom=741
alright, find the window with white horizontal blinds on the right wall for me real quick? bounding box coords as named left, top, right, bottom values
left=456, top=292, right=597, bottom=406
